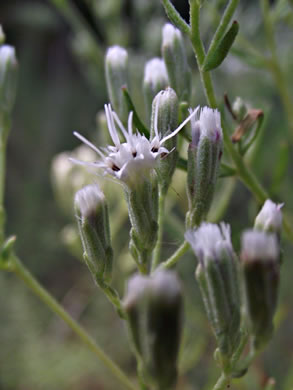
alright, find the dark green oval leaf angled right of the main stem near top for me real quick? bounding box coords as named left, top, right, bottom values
left=202, top=20, right=239, bottom=72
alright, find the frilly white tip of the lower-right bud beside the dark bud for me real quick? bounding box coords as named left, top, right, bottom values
left=185, top=222, right=233, bottom=263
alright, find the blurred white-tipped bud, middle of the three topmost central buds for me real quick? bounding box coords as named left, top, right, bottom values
left=143, top=58, right=169, bottom=118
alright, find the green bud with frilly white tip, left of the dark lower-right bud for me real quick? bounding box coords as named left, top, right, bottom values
left=185, top=223, right=240, bottom=357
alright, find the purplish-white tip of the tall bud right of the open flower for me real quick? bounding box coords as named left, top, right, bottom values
left=189, top=107, right=223, bottom=146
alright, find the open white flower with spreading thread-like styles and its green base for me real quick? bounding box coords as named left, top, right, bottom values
left=72, top=105, right=196, bottom=267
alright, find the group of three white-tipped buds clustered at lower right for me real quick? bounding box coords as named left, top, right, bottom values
left=185, top=200, right=282, bottom=364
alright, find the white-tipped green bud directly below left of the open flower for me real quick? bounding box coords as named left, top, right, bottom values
left=74, top=184, right=113, bottom=282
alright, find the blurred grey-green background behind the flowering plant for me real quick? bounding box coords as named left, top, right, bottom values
left=0, top=0, right=293, bottom=390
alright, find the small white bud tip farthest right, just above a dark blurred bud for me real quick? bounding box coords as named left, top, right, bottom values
left=255, top=199, right=284, bottom=232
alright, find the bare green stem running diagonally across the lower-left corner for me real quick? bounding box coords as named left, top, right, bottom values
left=11, top=256, right=136, bottom=390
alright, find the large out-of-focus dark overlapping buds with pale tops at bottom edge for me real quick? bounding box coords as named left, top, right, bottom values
left=124, top=271, right=182, bottom=390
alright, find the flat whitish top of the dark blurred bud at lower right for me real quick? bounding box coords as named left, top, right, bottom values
left=241, top=230, right=279, bottom=261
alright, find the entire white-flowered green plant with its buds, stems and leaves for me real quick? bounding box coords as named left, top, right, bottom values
left=0, top=0, right=292, bottom=390
